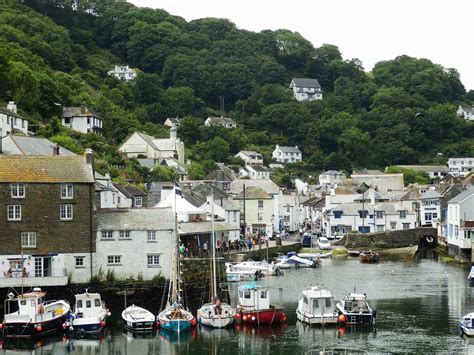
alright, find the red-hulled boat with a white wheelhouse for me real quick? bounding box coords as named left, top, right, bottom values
left=236, top=284, right=286, bottom=325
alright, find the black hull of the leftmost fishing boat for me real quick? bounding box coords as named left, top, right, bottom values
left=3, top=313, right=68, bottom=338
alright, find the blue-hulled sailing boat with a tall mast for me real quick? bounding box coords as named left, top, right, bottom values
left=156, top=184, right=197, bottom=334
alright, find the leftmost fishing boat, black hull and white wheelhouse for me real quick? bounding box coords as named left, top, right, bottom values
left=0, top=287, right=71, bottom=338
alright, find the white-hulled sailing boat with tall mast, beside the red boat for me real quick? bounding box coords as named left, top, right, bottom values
left=197, top=190, right=235, bottom=328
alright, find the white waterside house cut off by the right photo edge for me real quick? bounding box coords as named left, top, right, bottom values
left=446, top=185, right=474, bottom=260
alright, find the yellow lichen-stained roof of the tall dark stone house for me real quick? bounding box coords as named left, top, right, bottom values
left=0, top=155, right=94, bottom=183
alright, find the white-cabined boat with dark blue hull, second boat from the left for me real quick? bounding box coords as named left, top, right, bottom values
left=70, top=291, right=110, bottom=334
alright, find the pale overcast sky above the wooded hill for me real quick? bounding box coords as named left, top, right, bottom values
left=129, top=0, right=474, bottom=90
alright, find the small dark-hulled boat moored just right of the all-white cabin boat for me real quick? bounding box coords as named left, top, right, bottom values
left=336, top=293, right=377, bottom=325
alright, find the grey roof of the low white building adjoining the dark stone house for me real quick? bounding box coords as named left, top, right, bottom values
left=97, top=208, right=174, bottom=230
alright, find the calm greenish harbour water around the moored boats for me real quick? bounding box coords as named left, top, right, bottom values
left=0, top=254, right=474, bottom=355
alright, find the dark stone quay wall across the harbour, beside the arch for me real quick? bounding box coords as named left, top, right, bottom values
left=345, top=227, right=437, bottom=249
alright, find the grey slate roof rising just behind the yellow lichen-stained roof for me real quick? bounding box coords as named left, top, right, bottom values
left=2, top=134, right=76, bottom=156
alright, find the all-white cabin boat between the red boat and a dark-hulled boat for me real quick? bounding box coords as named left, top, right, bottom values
left=296, top=286, right=338, bottom=325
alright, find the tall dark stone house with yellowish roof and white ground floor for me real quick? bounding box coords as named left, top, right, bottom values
left=0, top=151, right=95, bottom=287
